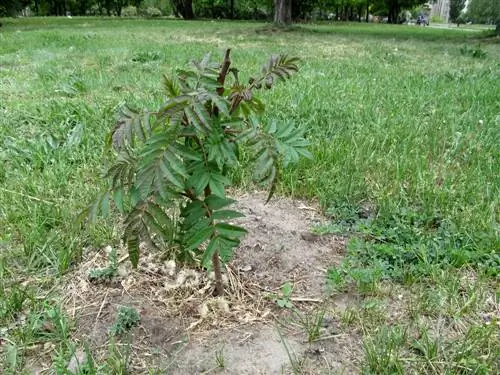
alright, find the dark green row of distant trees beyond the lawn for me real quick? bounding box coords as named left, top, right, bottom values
left=0, top=0, right=500, bottom=30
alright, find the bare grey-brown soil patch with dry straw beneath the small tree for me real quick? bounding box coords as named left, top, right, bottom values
left=51, top=193, right=361, bottom=374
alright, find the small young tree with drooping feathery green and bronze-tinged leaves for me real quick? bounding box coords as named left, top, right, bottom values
left=87, top=50, right=311, bottom=295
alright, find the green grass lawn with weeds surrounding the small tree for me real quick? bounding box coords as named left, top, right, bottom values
left=0, top=18, right=500, bottom=374
